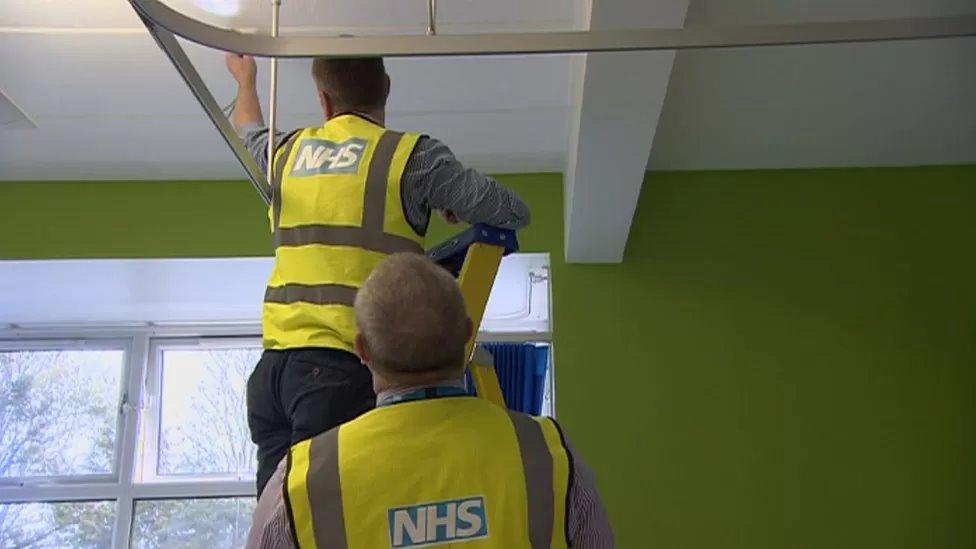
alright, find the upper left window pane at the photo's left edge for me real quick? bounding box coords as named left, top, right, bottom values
left=0, top=350, right=125, bottom=477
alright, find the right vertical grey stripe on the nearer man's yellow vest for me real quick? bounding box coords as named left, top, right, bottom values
left=508, top=410, right=562, bottom=549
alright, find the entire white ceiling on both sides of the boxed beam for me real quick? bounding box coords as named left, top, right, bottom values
left=0, top=0, right=976, bottom=180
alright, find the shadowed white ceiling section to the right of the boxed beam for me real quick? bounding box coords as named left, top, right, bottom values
left=649, top=0, right=976, bottom=170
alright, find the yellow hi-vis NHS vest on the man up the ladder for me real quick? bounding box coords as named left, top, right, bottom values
left=262, top=114, right=423, bottom=351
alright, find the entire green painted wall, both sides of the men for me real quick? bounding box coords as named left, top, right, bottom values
left=0, top=166, right=976, bottom=549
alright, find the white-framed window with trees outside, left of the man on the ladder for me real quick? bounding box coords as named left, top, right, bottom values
left=0, top=326, right=261, bottom=549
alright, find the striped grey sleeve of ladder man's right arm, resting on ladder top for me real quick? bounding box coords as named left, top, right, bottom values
left=401, top=136, right=530, bottom=234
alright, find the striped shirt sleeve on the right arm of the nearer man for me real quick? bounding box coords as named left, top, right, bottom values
left=566, top=442, right=614, bottom=549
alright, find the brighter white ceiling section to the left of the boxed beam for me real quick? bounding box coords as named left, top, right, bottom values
left=0, top=0, right=575, bottom=180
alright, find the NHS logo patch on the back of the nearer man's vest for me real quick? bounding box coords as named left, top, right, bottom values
left=387, top=496, right=488, bottom=547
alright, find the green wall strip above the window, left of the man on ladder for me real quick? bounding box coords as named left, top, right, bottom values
left=0, top=181, right=272, bottom=259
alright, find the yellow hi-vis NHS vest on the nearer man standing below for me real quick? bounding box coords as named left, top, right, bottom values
left=284, top=396, right=572, bottom=549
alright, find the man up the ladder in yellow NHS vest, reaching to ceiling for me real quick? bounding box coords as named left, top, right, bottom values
left=226, top=54, right=529, bottom=495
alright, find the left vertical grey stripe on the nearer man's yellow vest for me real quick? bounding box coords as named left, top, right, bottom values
left=306, top=427, right=346, bottom=549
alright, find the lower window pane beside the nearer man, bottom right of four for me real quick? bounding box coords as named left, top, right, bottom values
left=132, top=498, right=256, bottom=549
